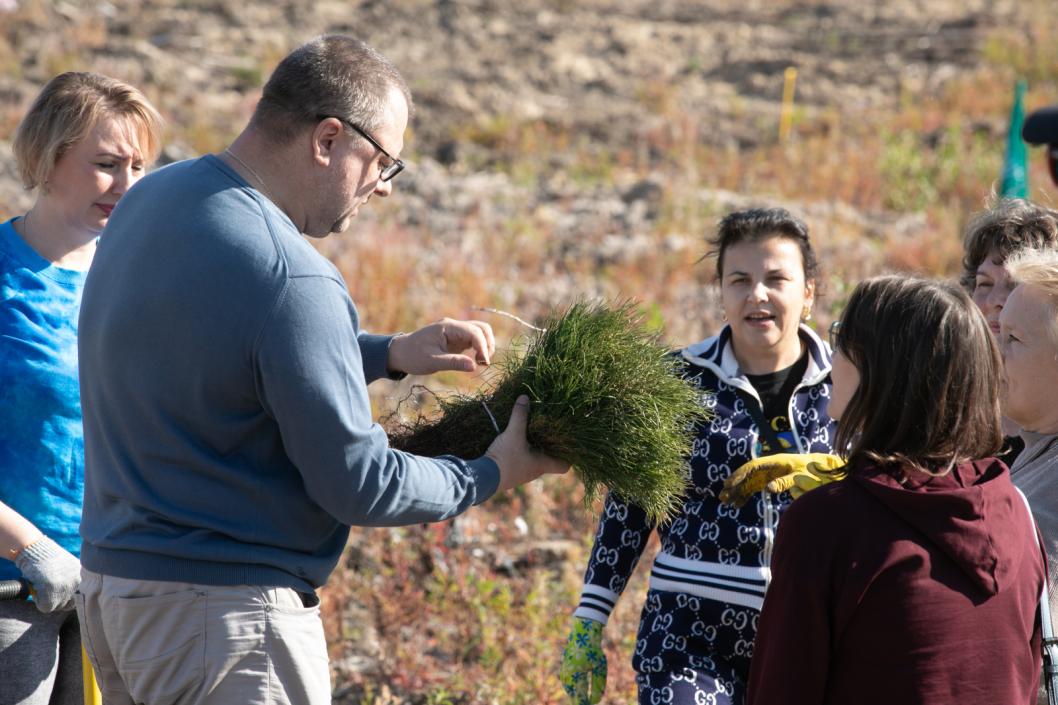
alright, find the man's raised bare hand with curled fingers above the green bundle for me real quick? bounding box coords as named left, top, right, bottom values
left=388, top=319, right=496, bottom=375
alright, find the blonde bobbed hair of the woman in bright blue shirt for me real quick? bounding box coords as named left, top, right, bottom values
left=12, top=71, right=164, bottom=189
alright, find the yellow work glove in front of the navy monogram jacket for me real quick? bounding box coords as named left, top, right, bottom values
left=720, top=453, right=847, bottom=507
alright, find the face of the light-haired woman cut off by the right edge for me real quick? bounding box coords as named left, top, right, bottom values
left=999, top=285, right=1058, bottom=433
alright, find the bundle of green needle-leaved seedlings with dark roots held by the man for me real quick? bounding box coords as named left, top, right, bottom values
left=390, top=303, right=705, bottom=521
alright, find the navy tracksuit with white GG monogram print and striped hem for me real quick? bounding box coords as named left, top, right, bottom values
left=574, top=326, right=836, bottom=705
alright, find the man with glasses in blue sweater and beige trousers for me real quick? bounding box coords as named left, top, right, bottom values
left=77, top=36, right=568, bottom=705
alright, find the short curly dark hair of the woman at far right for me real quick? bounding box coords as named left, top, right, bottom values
left=960, top=198, right=1058, bottom=293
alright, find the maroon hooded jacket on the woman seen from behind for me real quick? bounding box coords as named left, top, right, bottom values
left=749, top=458, right=1044, bottom=705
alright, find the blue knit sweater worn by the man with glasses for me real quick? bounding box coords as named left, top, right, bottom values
left=79, top=157, right=498, bottom=590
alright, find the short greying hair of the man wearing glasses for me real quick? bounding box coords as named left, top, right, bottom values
left=250, top=34, right=413, bottom=143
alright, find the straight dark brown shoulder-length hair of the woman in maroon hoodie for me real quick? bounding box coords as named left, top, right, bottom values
left=836, top=276, right=1002, bottom=473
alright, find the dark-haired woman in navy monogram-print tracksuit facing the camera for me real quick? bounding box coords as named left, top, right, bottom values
left=561, top=209, right=835, bottom=705
